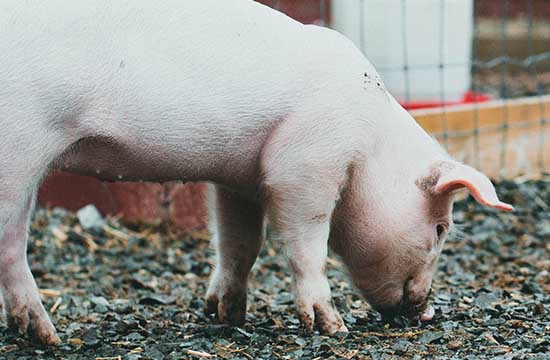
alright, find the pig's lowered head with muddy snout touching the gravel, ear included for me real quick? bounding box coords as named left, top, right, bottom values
left=330, top=160, right=513, bottom=320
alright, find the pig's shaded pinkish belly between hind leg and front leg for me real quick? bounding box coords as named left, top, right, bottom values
left=59, top=129, right=272, bottom=192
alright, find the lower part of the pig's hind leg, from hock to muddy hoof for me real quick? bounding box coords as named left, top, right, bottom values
left=0, top=194, right=60, bottom=345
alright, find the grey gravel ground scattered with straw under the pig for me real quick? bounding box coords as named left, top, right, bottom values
left=0, top=179, right=550, bottom=359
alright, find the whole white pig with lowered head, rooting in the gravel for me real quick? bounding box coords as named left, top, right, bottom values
left=0, top=0, right=512, bottom=344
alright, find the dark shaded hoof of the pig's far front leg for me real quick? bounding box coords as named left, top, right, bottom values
left=204, top=290, right=246, bottom=326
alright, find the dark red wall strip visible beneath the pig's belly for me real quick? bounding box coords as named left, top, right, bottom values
left=38, top=172, right=207, bottom=229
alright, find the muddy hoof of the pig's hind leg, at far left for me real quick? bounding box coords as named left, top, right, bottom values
left=6, top=304, right=61, bottom=345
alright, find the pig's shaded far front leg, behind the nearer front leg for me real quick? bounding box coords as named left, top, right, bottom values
left=205, top=187, right=263, bottom=325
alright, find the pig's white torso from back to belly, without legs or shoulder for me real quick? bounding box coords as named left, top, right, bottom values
left=0, top=0, right=344, bottom=190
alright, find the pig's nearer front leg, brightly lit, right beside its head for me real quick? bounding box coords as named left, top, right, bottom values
left=267, top=172, right=348, bottom=334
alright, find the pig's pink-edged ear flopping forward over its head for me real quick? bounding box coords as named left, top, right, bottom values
left=433, top=164, right=514, bottom=211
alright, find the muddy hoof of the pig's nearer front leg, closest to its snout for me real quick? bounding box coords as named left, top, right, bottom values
left=298, top=301, right=348, bottom=335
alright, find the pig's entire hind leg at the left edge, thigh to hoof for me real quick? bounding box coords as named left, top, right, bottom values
left=0, top=122, right=70, bottom=344
